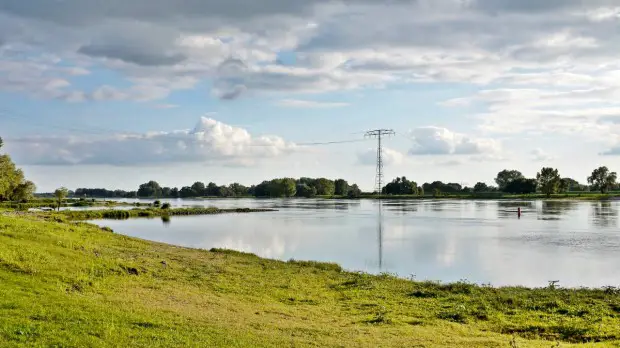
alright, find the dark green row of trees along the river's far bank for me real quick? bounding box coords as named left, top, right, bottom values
left=71, top=167, right=618, bottom=198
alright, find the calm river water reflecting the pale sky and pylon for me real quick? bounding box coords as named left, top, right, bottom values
left=94, top=199, right=620, bottom=287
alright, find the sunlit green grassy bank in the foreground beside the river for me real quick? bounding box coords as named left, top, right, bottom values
left=0, top=215, right=620, bottom=347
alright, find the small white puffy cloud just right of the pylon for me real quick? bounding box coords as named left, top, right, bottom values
left=409, top=127, right=501, bottom=156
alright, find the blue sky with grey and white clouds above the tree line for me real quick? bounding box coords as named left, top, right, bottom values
left=0, top=0, right=620, bottom=192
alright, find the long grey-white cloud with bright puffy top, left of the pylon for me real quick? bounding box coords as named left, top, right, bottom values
left=7, top=117, right=297, bottom=166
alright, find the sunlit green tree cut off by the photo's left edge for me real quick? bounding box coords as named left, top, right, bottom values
left=0, top=138, right=36, bottom=201
